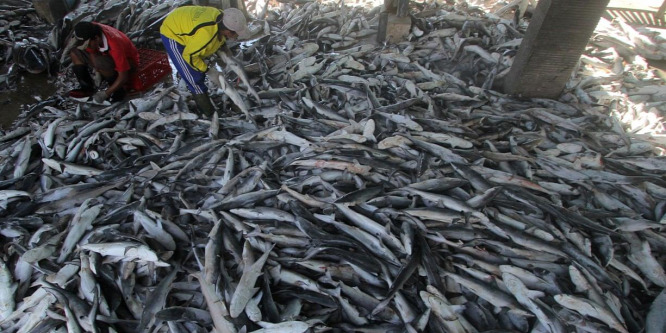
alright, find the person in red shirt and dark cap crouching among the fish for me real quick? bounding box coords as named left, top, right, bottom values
left=69, top=22, right=139, bottom=103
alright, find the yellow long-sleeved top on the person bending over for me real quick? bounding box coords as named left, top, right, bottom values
left=160, top=6, right=226, bottom=72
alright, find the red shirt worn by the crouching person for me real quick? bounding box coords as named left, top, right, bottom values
left=86, top=22, right=139, bottom=72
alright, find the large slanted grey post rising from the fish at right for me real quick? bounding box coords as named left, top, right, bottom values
left=504, top=0, right=609, bottom=98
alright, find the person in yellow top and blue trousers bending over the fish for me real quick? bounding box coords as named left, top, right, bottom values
left=160, top=6, right=247, bottom=116
